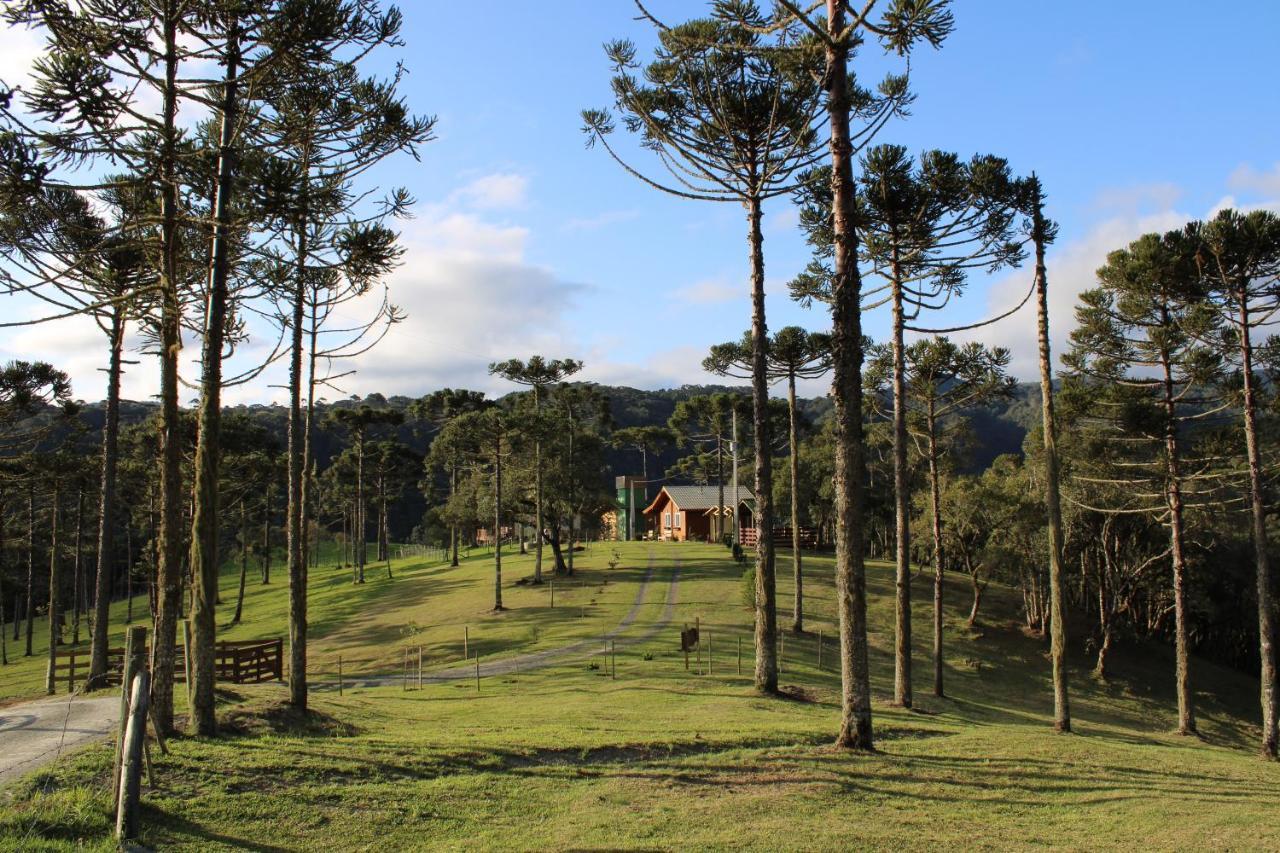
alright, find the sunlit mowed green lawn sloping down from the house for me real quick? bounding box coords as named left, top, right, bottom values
left=0, top=543, right=1280, bottom=850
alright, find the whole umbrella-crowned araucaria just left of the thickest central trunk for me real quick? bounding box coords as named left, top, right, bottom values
left=582, top=0, right=824, bottom=693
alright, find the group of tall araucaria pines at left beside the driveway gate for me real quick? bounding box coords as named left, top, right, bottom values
left=0, top=0, right=434, bottom=734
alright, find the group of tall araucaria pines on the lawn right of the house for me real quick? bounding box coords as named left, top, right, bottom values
left=582, top=0, right=1277, bottom=756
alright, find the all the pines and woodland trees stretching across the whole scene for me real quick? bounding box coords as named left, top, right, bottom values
left=0, top=0, right=1280, bottom=756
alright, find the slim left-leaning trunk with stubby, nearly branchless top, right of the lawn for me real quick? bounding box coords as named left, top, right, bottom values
left=1032, top=188, right=1071, bottom=731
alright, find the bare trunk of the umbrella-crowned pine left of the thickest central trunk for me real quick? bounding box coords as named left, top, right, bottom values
left=733, top=190, right=778, bottom=693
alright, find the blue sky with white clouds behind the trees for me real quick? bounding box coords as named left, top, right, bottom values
left=0, top=0, right=1280, bottom=400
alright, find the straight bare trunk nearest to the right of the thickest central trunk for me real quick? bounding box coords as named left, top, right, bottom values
left=892, top=256, right=911, bottom=708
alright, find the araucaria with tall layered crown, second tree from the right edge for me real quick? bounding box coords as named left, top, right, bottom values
left=1064, top=232, right=1224, bottom=735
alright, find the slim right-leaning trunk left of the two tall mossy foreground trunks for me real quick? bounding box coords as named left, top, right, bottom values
left=88, top=306, right=123, bottom=690
